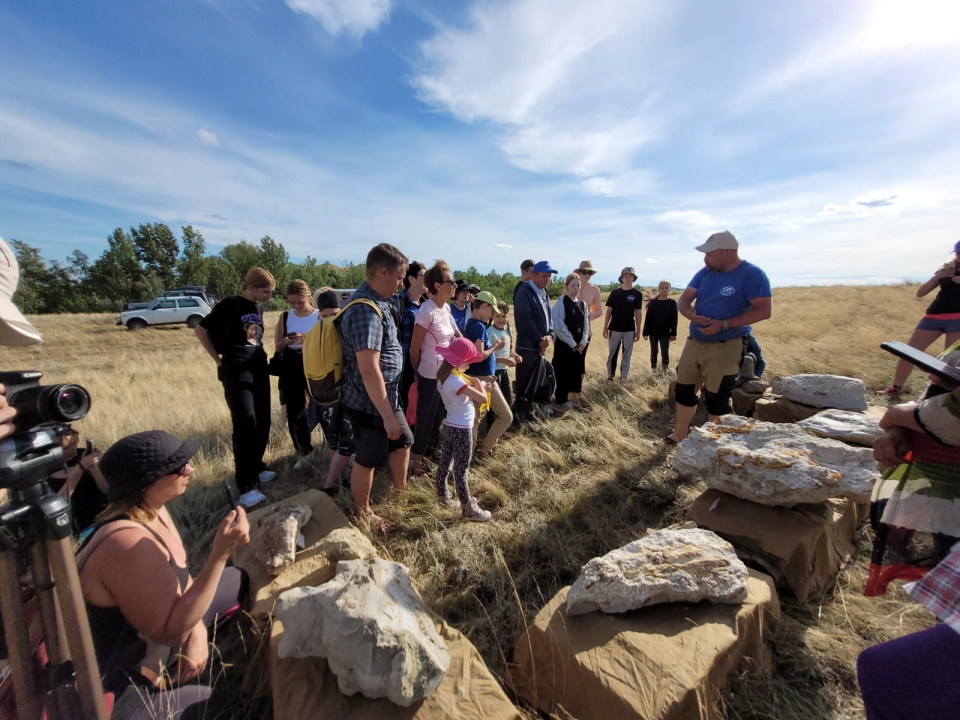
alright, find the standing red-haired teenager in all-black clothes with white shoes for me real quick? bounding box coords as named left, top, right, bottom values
left=195, top=268, right=277, bottom=507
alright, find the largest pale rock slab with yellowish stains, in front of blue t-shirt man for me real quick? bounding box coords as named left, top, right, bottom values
left=672, top=415, right=880, bottom=506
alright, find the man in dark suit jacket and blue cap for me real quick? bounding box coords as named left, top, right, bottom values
left=513, top=260, right=557, bottom=420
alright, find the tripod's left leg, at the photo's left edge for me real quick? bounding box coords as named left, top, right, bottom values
left=0, top=550, right=40, bottom=720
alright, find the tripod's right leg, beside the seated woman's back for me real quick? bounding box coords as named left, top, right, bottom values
left=47, top=537, right=107, bottom=720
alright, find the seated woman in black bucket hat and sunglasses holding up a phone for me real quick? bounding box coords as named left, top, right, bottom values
left=77, top=430, right=250, bottom=718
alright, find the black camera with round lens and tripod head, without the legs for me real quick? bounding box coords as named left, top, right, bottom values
left=0, top=370, right=90, bottom=496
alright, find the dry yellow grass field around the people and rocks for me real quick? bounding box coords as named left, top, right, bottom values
left=0, top=285, right=944, bottom=720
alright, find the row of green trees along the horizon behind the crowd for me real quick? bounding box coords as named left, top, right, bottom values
left=10, top=223, right=604, bottom=314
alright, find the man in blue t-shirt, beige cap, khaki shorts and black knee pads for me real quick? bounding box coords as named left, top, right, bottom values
left=664, top=231, right=773, bottom=444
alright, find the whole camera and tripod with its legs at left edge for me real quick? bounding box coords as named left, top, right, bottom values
left=0, top=370, right=107, bottom=720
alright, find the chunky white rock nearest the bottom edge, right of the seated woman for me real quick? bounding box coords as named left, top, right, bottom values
left=275, top=558, right=450, bottom=707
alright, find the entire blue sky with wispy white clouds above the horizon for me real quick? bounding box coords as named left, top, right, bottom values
left=0, top=0, right=960, bottom=286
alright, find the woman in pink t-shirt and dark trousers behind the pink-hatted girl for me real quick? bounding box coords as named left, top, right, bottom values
left=410, top=260, right=460, bottom=475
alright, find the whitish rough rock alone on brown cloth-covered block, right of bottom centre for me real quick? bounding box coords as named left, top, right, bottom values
left=567, top=528, right=747, bottom=615
